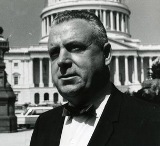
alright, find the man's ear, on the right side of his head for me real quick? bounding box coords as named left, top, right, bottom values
left=103, top=43, right=112, bottom=65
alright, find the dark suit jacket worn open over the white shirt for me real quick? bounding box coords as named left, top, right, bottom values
left=30, top=86, right=160, bottom=146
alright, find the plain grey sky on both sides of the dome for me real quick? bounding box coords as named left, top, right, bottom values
left=0, top=0, right=160, bottom=47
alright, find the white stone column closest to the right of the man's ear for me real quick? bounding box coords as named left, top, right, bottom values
left=114, top=56, right=121, bottom=85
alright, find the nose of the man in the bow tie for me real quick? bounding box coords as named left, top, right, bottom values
left=57, top=48, right=72, bottom=68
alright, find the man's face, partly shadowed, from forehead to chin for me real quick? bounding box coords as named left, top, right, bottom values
left=48, top=19, right=110, bottom=104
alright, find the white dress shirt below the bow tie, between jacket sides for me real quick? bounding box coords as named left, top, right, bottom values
left=59, top=95, right=110, bottom=146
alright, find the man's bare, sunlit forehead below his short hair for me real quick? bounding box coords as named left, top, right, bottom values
left=49, top=19, right=93, bottom=41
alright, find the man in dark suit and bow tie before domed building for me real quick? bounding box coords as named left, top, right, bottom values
left=30, top=11, right=160, bottom=146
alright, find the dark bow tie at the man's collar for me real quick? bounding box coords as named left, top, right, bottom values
left=62, top=104, right=96, bottom=117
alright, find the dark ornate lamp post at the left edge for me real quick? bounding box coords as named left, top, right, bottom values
left=0, top=27, right=17, bottom=133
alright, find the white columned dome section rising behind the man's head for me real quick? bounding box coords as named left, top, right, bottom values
left=40, top=0, right=130, bottom=44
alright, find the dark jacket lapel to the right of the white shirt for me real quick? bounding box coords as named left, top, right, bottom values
left=88, top=85, right=122, bottom=146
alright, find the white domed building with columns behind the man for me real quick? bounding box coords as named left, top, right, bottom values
left=4, top=0, right=160, bottom=104
